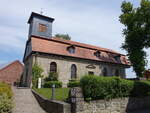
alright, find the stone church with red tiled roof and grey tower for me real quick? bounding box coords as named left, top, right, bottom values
left=23, top=13, right=130, bottom=86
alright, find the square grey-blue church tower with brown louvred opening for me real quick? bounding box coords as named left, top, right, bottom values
left=28, top=12, right=54, bottom=38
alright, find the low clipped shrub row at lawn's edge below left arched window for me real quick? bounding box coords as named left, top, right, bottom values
left=44, top=81, right=62, bottom=88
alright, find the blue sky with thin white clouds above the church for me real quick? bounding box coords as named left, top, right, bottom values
left=0, top=0, right=150, bottom=77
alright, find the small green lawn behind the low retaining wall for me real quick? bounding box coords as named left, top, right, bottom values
left=34, top=88, right=69, bottom=101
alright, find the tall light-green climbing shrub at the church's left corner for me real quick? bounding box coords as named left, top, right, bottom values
left=32, top=63, right=43, bottom=87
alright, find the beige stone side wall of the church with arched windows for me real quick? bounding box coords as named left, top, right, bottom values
left=33, top=55, right=125, bottom=87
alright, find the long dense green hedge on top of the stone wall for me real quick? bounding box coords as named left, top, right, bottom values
left=80, top=75, right=150, bottom=100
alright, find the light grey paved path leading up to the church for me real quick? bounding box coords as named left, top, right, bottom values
left=12, top=87, right=46, bottom=113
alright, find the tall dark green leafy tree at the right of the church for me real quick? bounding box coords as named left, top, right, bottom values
left=120, top=0, right=150, bottom=77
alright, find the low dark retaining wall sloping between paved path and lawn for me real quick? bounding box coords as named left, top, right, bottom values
left=32, top=90, right=71, bottom=113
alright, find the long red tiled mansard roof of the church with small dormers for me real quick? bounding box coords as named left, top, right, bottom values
left=28, top=36, right=130, bottom=65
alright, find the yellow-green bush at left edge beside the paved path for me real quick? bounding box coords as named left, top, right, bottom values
left=0, top=83, right=13, bottom=113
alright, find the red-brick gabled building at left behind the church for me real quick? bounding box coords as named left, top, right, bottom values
left=0, top=60, right=23, bottom=85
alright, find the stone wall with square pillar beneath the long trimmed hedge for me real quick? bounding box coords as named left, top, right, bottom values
left=70, top=88, right=150, bottom=113
